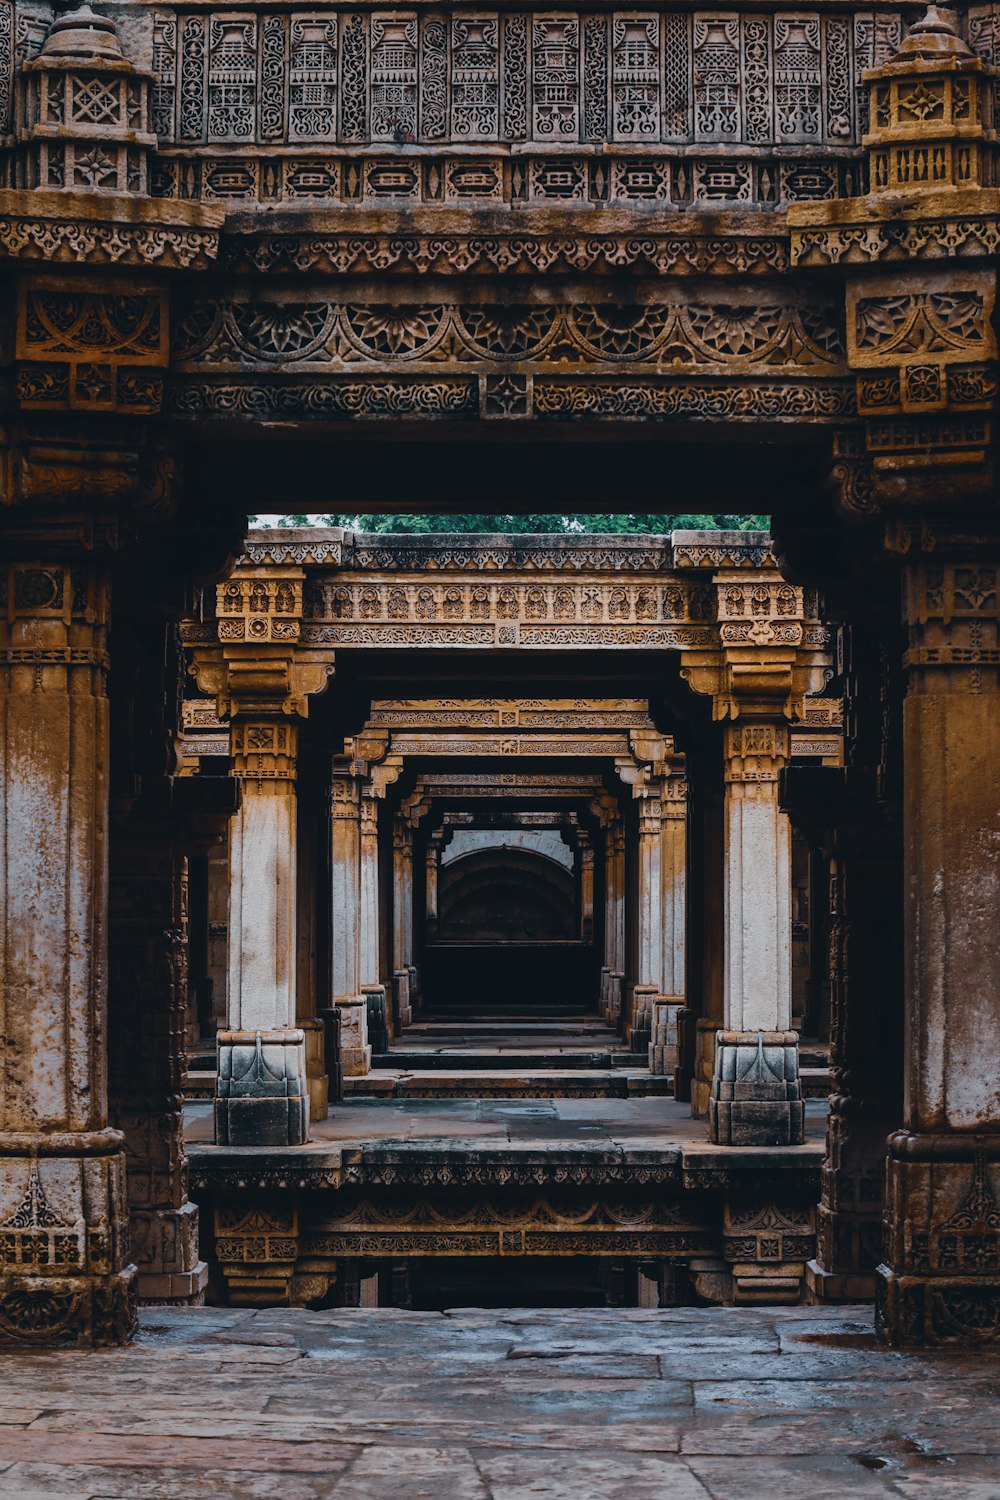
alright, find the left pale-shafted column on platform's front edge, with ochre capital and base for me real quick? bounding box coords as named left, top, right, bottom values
left=195, top=564, right=333, bottom=1146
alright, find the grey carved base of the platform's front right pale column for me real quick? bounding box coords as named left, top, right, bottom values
left=709, top=1032, right=805, bottom=1146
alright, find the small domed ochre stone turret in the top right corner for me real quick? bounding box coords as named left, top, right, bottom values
left=864, top=5, right=997, bottom=194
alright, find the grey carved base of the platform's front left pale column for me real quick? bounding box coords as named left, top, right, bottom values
left=216, top=1031, right=309, bottom=1146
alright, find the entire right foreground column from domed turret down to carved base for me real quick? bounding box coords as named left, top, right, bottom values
left=789, top=6, right=1000, bottom=1344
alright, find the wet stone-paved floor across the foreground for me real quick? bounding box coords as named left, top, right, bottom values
left=0, top=1308, right=1000, bottom=1500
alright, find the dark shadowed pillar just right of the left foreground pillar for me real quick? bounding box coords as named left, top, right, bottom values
left=108, top=612, right=212, bottom=1304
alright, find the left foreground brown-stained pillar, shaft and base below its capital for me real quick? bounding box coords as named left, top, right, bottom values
left=0, top=560, right=136, bottom=1346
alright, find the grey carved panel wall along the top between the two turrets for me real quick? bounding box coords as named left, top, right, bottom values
left=140, top=8, right=923, bottom=206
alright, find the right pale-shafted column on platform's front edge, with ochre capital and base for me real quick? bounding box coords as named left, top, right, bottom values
left=682, top=566, right=831, bottom=1146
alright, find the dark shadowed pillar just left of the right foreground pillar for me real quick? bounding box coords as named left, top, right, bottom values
left=783, top=609, right=904, bottom=1302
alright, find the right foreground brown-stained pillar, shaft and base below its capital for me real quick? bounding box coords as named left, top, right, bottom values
left=879, top=555, right=1000, bottom=1344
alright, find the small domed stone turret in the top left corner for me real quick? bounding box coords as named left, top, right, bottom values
left=16, top=5, right=156, bottom=197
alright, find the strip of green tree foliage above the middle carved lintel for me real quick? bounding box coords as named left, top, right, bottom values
left=250, top=512, right=769, bottom=536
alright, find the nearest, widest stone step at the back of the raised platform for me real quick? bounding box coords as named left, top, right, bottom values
left=343, top=1068, right=673, bottom=1100
